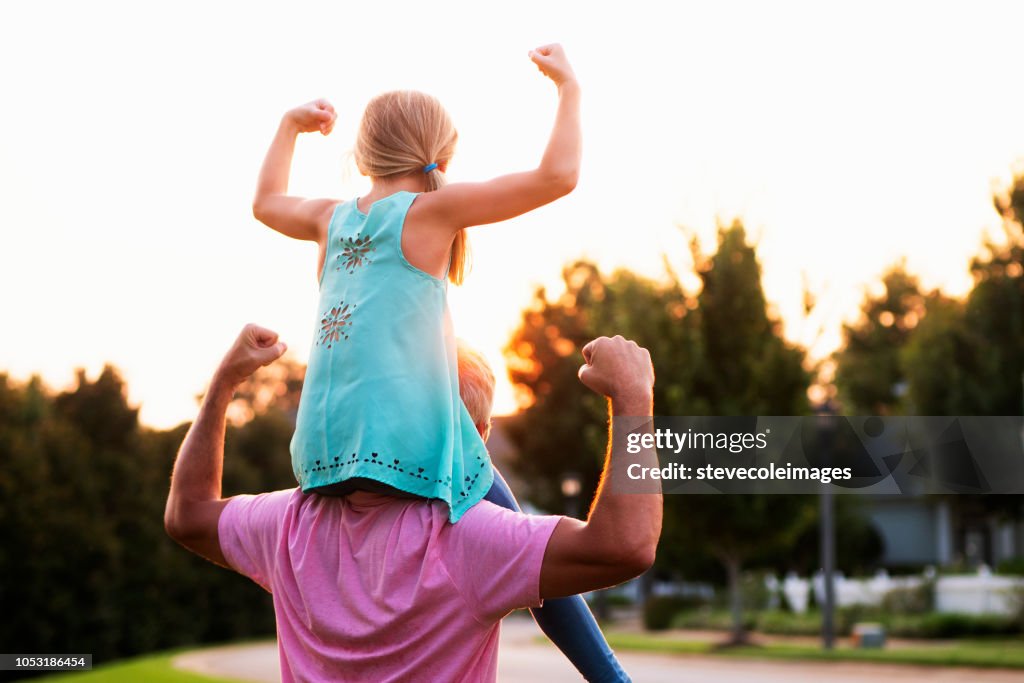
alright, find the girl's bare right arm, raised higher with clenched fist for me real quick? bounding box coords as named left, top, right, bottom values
left=414, top=44, right=583, bottom=232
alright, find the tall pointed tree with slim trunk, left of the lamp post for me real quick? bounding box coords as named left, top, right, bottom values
left=663, top=221, right=816, bottom=643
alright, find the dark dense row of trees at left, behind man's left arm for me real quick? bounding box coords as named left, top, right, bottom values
left=0, top=367, right=294, bottom=660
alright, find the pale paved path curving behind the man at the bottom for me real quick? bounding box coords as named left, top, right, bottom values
left=174, top=615, right=1024, bottom=683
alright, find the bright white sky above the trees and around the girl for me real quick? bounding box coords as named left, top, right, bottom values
left=0, top=0, right=1024, bottom=427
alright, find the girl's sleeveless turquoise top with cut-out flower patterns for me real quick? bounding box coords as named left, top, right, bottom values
left=291, top=191, right=494, bottom=523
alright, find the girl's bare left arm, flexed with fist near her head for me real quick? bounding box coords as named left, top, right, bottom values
left=253, top=99, right=338, bottom=243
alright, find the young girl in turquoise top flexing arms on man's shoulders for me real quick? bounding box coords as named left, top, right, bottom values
left=253, top=45, right=627, bottom=680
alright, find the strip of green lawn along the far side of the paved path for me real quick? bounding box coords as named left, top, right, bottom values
left=606, top=631, right=1024, bottom=669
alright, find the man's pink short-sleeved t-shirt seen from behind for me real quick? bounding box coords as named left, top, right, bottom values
left=219, top=488, right=559, bottom=683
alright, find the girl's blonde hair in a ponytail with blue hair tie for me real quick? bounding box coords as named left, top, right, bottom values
left=354, top=90, right=469, bottom=285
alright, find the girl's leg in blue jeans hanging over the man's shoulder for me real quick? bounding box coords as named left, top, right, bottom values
left=483, top=468, right=630, bottom=683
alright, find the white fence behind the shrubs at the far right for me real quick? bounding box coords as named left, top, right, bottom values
left=774, top=567, right=1024, bottom=616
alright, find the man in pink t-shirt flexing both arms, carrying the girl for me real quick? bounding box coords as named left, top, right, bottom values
left=165, top=326, right=662, bottom=682
